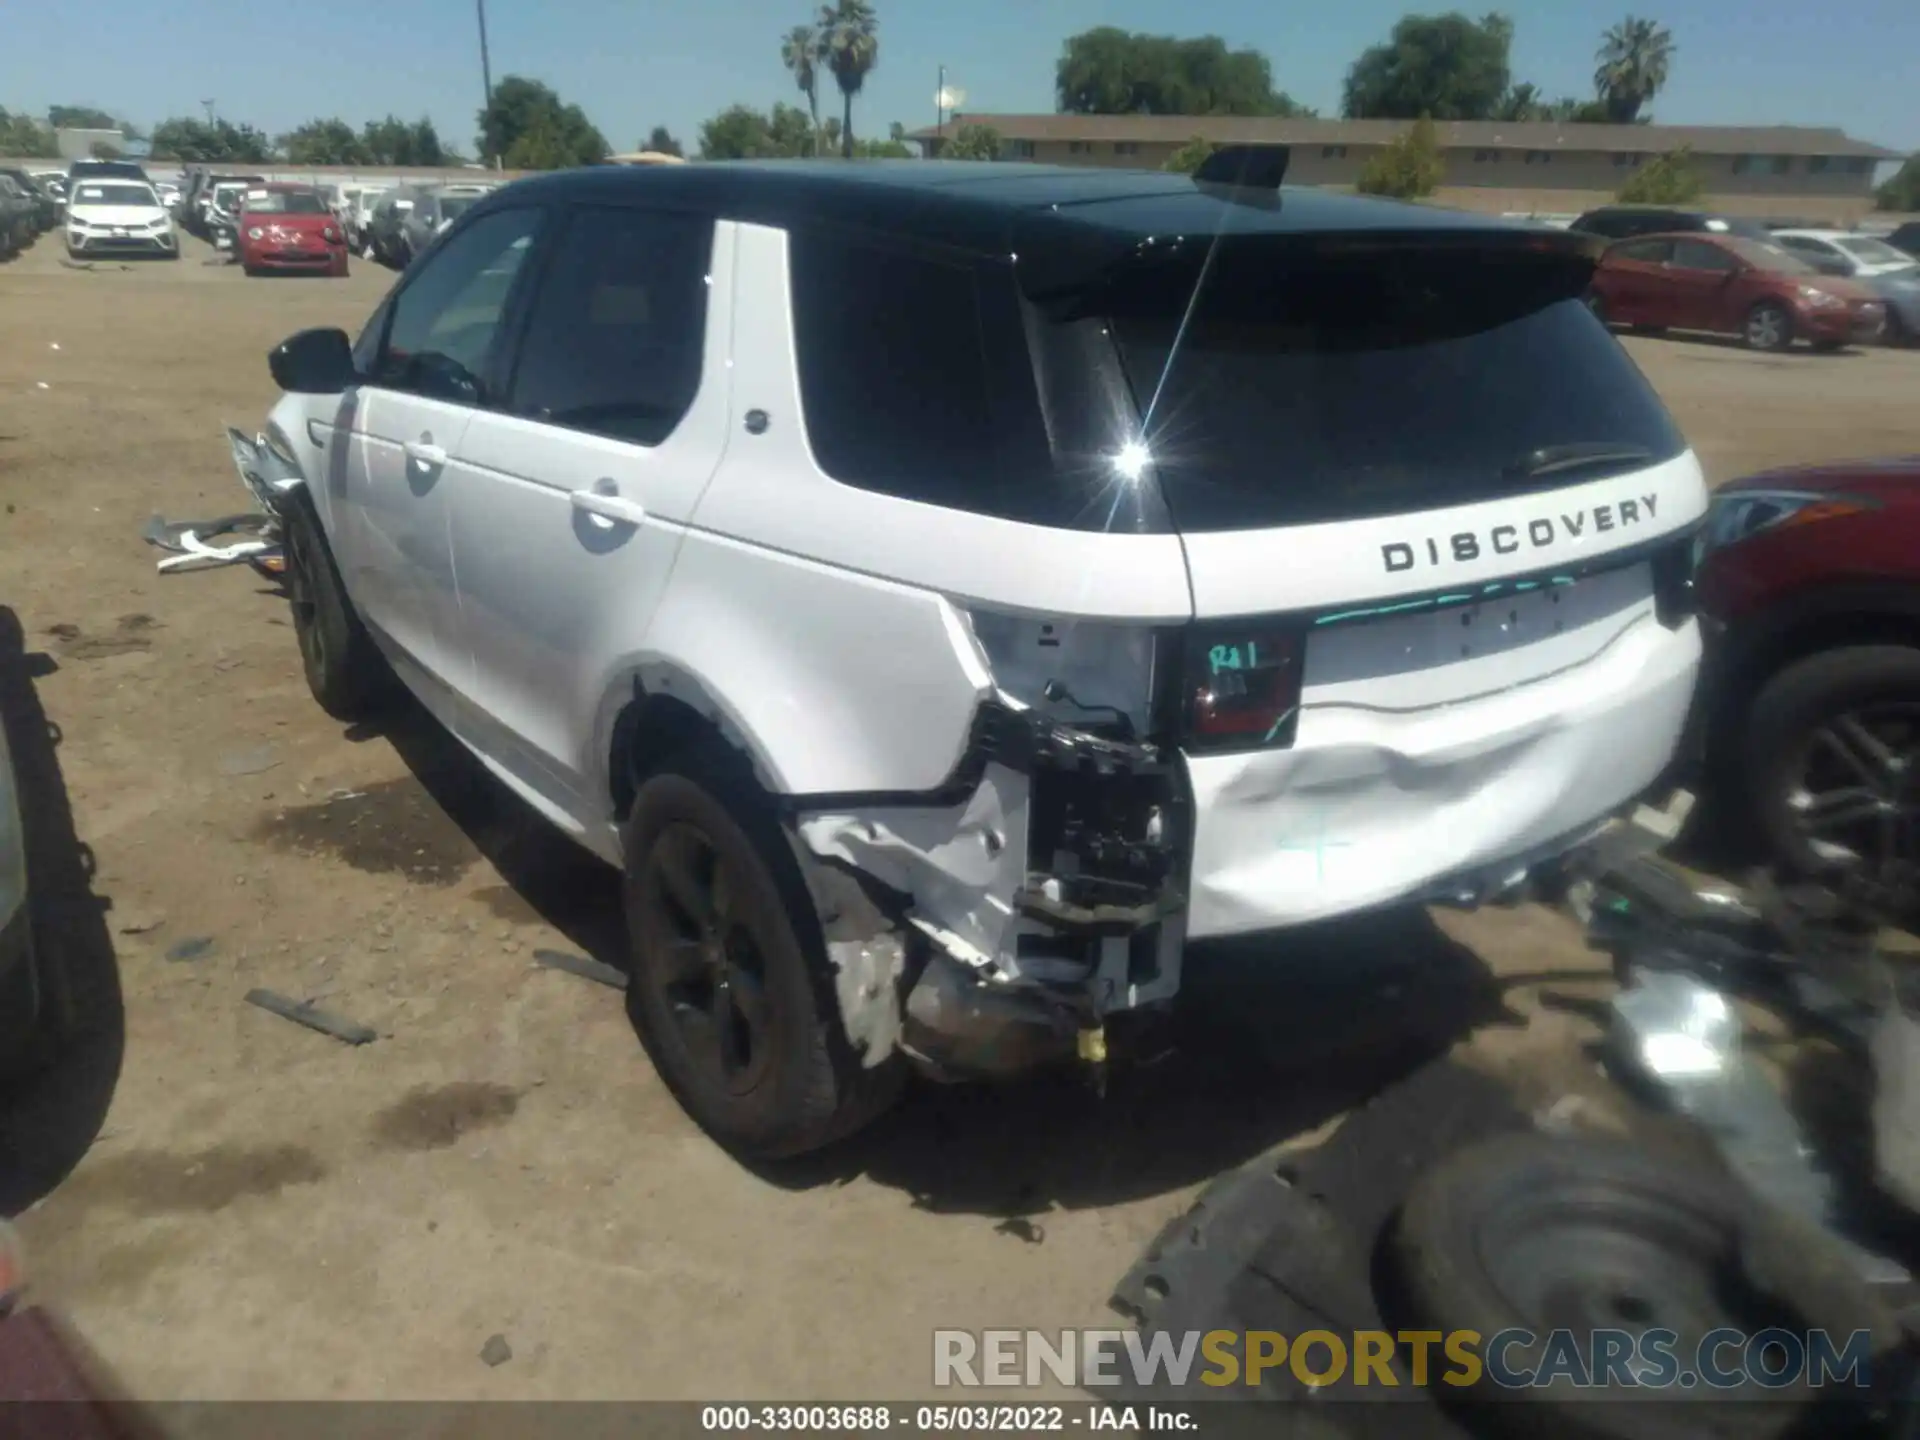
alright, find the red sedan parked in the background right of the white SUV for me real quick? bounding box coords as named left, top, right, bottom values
left=1588, top=234, right=1887, bottom=349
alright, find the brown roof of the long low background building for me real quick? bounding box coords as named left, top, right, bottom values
left=908, top=111, right=1905, bottom=159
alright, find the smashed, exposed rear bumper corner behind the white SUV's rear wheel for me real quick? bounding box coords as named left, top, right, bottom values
left=793, top=701, right=1190, bottom=1079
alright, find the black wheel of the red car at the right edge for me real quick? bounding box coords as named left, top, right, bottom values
left=1743, top=645, right=1920, bottom=914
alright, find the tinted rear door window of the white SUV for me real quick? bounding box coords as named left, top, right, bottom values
left=511, top=209, right=714, bottom=445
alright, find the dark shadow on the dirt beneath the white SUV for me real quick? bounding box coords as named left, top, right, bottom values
left=349, top=703, right=1523, bottom=1240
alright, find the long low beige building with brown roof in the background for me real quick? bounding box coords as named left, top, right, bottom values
left=910, top=113, right=1901, bottom=219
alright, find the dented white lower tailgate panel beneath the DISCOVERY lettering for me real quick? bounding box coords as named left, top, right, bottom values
left=1187, top=605, right=1699, bottom=937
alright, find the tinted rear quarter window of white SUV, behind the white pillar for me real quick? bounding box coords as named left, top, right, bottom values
left=787, top=228, right=1105, bottom=530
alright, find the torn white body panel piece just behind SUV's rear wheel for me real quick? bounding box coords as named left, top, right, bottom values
left=799, top=764, right=1027, bottom=972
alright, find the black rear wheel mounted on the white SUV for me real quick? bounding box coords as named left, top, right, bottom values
left=624, top=755, right=900, bottom=1160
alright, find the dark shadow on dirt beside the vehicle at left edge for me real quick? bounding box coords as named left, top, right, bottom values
left=0, top=607, right=127, bottom=1215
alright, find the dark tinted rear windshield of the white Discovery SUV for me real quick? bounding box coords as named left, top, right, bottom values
left=1112, top=252, right=1686, bottom=530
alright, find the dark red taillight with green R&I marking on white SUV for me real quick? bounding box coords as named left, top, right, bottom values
left=1187, top=622, right=1306, bottom=751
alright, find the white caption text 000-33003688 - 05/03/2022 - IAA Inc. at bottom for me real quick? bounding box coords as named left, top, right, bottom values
left=701, top=1404, right=1200, bottom=1436
